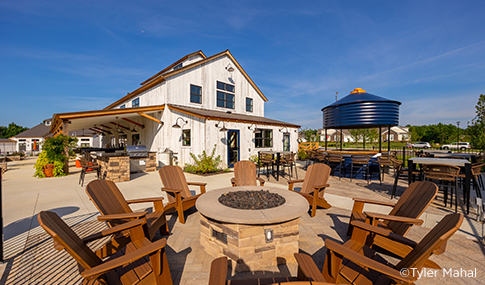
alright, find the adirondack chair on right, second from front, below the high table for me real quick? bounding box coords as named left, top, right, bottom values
left=347, top=181, right=438, bottom=252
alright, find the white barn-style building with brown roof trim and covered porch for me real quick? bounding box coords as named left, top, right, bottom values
left=51, top=50, right=300, bottom=167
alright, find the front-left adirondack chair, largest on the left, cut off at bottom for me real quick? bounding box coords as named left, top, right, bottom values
left=37, top=211, right=173, bottom=285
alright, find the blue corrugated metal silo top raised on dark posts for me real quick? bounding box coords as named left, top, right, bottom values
left=322, top=88, right=401, bottom=129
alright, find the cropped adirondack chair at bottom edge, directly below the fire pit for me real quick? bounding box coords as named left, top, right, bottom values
left=209, top=256, right=330, bottom=285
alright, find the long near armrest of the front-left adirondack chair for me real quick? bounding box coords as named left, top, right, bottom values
left=81, top=239, right=167, bottom=280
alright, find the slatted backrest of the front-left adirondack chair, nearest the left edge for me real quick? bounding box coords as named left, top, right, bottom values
left=37, top=211, right=102, bottom=271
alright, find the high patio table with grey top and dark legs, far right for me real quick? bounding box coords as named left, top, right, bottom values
left=408, top=157, right=472, bottom=215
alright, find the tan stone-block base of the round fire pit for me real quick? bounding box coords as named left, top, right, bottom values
left=200, top=215, right=300, bottom=272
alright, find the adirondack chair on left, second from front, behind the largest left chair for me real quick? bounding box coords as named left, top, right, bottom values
left=86, top=180, right=169, bottom=255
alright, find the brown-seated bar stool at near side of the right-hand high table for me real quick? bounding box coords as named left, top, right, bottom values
left=422, top=164, right=460, bottom=213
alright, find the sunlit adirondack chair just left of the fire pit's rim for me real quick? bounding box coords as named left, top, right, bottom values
left=158, top=165, right=207, bottom=224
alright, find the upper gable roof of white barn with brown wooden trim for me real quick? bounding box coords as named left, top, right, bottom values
left=104, top=50, right=268, bottom=110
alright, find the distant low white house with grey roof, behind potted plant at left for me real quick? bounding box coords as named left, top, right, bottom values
left=12, top=119, right=96, bottom=154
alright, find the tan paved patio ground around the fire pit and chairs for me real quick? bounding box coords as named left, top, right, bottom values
left=0, top=157, right=485, bottom=284
